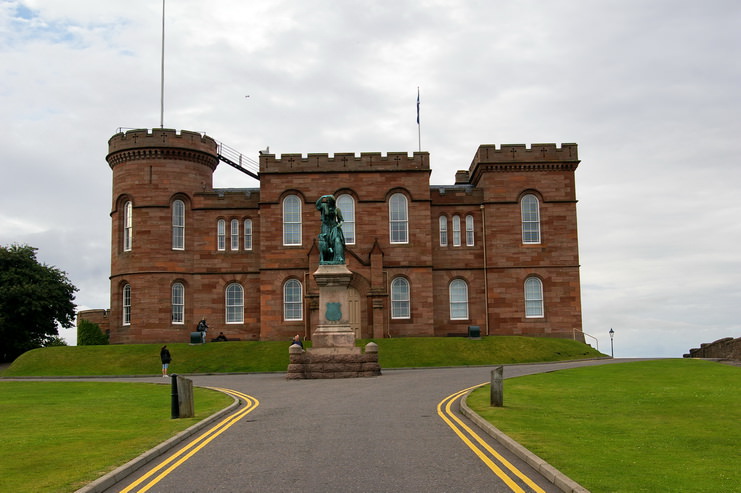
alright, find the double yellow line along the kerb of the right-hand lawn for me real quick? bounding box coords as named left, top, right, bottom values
left=437, top=383, right=545, bottom=493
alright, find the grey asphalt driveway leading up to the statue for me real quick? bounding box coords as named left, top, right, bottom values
left=85, top=360, right=640, bottom=493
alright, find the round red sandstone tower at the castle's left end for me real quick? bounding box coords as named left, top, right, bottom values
left=106, top=129, right=219, bottom=343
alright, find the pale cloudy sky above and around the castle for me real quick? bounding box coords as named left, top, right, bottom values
left=0, top=0, right=741, bottom=357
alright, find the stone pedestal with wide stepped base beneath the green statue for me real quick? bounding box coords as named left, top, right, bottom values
left=286, top=264, right=381, bottom=380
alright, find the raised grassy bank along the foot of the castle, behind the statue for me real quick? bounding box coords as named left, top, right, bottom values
left=0, top=336, right=605, bottom=377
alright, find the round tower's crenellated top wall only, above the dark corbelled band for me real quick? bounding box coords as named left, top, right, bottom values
left=108, top=128, right=217, bottom=157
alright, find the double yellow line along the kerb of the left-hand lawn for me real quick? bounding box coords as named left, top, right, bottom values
left=121, top=387, right=260, bottom=493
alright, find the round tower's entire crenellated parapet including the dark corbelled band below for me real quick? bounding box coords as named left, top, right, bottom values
left=106, top=128, right=219, bottom=170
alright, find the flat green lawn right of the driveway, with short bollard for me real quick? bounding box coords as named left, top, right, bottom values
left=467, top=360, right=741, bottom=493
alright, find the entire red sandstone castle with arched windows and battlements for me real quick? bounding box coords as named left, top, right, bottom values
left=81, top=129, right=581, bottom=343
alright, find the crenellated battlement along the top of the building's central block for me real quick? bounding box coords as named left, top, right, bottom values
left=260, top=152, right=430, bottom=174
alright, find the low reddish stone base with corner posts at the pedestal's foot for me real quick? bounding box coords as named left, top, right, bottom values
left=286, top=342, right=381, bottom=380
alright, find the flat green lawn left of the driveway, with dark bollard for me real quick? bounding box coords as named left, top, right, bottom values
left=0, top=381, right=232, bottom=493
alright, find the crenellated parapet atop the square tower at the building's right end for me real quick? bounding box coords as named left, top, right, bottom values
left=468, top=144, right=579, bottom=183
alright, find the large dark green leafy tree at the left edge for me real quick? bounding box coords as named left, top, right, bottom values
left=0, top=245, right=77, bottom=360
